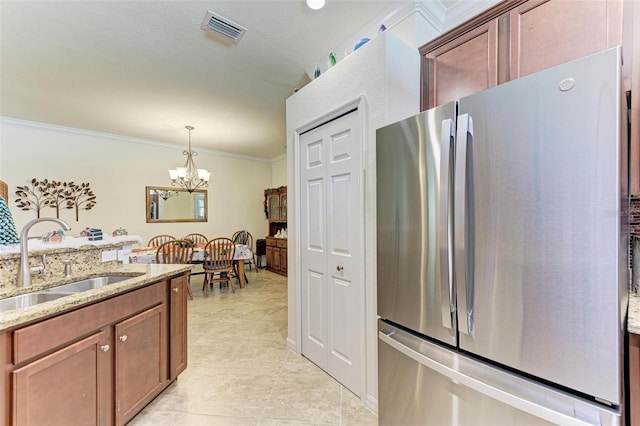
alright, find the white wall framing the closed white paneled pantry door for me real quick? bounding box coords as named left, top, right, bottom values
left=287, top=32, right=420, bottom=410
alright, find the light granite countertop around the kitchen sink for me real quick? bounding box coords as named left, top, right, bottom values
left=0, top=264, right=192, bottom=330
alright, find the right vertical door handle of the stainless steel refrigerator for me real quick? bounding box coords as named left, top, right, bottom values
left=453, top=114, right=473, bottom=334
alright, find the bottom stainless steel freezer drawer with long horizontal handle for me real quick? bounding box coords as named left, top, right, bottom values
left=378, top=321, right=622, bottom=426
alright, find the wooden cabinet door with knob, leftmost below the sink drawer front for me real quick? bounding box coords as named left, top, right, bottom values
left=11, top=331, right=111, bottom=425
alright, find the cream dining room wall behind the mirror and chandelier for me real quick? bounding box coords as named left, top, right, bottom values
left=0, top=118, right=272, bottom=242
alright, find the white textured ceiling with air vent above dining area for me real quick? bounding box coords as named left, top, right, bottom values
left=0, top=0, right=438, bottom=159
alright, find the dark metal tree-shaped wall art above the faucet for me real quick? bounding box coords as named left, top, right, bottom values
left=16, top=178, right=96, bottom=222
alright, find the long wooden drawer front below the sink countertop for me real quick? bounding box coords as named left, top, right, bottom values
left=12, top=281, right=167, bottom=364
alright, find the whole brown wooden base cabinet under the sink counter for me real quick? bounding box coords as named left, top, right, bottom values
left=0, top=275, right=188, bottom=426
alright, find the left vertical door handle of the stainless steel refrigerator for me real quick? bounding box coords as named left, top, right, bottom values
left=438, top=118, right=455, bottom=328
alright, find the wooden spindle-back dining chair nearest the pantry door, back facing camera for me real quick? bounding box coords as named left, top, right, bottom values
left=202, top=237, right=236, bottom=297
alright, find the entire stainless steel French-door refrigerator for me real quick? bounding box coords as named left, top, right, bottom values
left=376, top=48, right=629, bottom=426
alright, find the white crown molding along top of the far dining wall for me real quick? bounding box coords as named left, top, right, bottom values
left=0, top=117, right=279, bottom=163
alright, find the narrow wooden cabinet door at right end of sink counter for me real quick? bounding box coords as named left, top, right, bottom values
left=169, top=275, right=189, bottom=380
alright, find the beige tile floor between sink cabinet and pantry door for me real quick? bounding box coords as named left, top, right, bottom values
left=129, top=269, right=378, bottom=426
